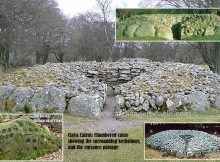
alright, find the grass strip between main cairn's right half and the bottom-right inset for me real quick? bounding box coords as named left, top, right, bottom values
left=119, top=108, right=220, bottom=122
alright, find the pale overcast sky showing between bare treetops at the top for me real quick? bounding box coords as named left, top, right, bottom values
left=56, top=0, right=141, bottom=17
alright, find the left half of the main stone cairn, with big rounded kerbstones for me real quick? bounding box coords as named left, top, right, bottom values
left=0, top=62, right=107, bottom=117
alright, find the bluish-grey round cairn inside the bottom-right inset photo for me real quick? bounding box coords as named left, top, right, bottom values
left=146, top=130, right=220, bottom=158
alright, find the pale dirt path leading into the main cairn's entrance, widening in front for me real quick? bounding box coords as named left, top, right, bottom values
left=64, top=96, right=143, bottom=132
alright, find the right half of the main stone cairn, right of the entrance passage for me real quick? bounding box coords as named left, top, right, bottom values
left=115, top=62, right=220, bottom=114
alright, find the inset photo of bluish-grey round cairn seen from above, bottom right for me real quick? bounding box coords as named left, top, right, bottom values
left=145, top=123, right=220, bottom=160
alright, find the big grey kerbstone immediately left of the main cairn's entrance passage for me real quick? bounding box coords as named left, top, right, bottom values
left=67, top=94, right=101, bottom=118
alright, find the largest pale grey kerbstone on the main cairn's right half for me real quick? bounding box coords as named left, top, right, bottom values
left=188, top=92, right=210, bottom=111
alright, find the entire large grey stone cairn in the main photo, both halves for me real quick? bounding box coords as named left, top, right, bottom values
left=0, top=58, right=220, bottom=118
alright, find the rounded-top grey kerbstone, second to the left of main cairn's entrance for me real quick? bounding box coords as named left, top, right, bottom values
left=31, top=86, right=66, bottom=113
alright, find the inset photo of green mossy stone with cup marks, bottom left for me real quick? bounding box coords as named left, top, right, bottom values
left=0, top=114, right=63, bottom=161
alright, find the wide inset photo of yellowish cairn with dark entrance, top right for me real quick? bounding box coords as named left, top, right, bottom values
left=116, top=9, right=220, bottom=41
